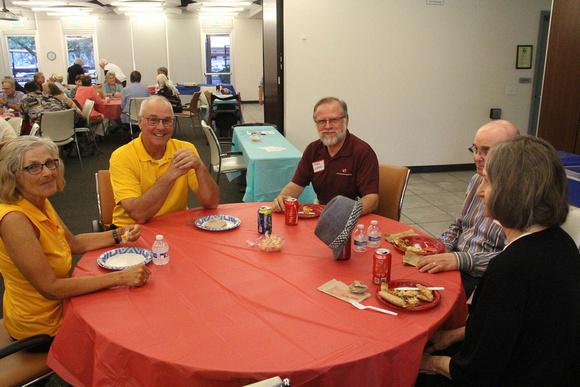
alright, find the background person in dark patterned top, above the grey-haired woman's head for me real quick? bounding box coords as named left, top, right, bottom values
left=20, top=81, right=69, bottom=130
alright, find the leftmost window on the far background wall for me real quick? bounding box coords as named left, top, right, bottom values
left=6, top=35, right=38, bottom=85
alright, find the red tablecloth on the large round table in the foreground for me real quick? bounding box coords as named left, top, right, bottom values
left=48, top=203, right=467, bottom=386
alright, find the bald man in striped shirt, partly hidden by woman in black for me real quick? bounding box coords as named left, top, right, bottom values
left=417, top=120, right=519, bottom=298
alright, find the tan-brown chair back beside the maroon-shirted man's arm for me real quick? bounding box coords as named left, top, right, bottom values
left=374, top=164, right=410, bottom=221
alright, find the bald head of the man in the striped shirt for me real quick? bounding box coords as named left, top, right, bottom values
left=472, top=120, right=520, bottom=175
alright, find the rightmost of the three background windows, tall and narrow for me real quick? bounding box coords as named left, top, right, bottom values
left=205, top=34, right=232, bottom=85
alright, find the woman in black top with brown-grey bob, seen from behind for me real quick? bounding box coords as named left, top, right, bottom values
left=416, top=136, right=580, bottom=386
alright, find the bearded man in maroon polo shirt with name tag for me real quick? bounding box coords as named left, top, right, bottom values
left=272, top=97, right=379, bottom=215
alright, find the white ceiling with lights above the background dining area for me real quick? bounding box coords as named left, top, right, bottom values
left=4, top=0, right=262, bottom=18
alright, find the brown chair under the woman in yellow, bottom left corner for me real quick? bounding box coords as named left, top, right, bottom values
left=0, top=319, right=52, bottom=386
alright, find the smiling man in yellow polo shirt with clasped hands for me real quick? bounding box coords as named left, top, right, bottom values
left=109, top=96, right=220, bottom=227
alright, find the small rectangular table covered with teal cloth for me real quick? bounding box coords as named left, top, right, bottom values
left=232, top=126, right=316, bottom=203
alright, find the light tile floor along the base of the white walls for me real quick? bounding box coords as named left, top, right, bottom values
left=242, top=104, right=475, bottom=238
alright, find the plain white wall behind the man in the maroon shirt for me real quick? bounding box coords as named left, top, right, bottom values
left=284, top=0, right=551, bottom=166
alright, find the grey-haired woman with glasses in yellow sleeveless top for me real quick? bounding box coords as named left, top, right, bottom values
left=0, top=136, right=151, bottom=352
